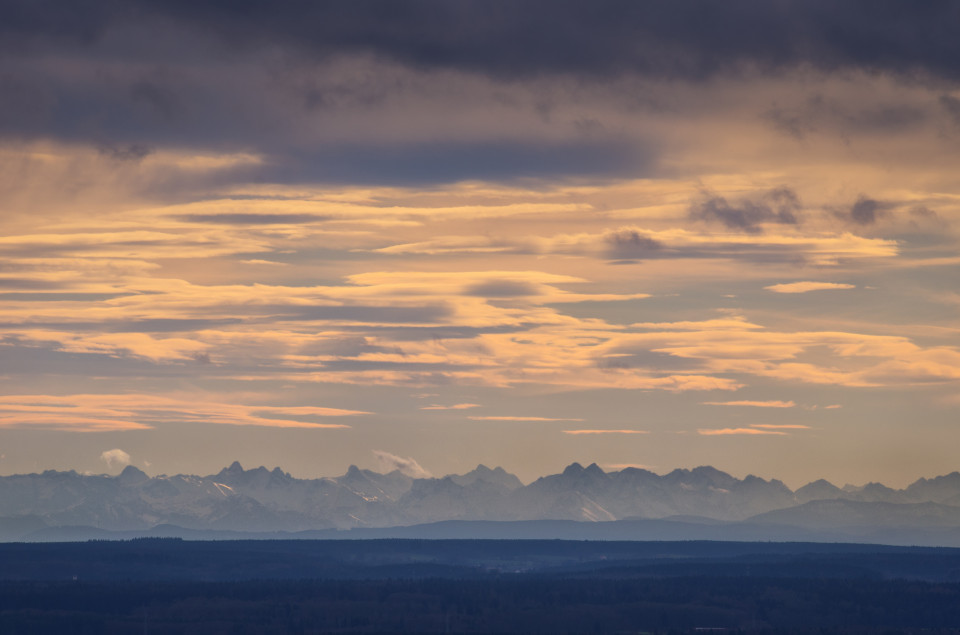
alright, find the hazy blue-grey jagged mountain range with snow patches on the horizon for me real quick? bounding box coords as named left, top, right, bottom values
left=0, top=462, right=960, bottom=540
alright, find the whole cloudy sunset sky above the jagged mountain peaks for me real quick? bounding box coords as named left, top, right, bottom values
left=0, top=0, right=960, bottom=487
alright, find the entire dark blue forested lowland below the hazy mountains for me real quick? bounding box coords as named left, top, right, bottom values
left=0, top=540, right=960, bottom=635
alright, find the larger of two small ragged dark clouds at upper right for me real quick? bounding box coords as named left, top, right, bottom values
left=690, top=187, right=800, bottom=234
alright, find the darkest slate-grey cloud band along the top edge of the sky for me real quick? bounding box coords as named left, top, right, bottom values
left=7, top=0, right=960, bottom=82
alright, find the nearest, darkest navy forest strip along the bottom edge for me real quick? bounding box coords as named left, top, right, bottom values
left=0, top=576, right=960, bottom=635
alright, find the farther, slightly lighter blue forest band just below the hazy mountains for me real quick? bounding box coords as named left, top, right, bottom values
left=0, top=539, right=960, bottom=582
